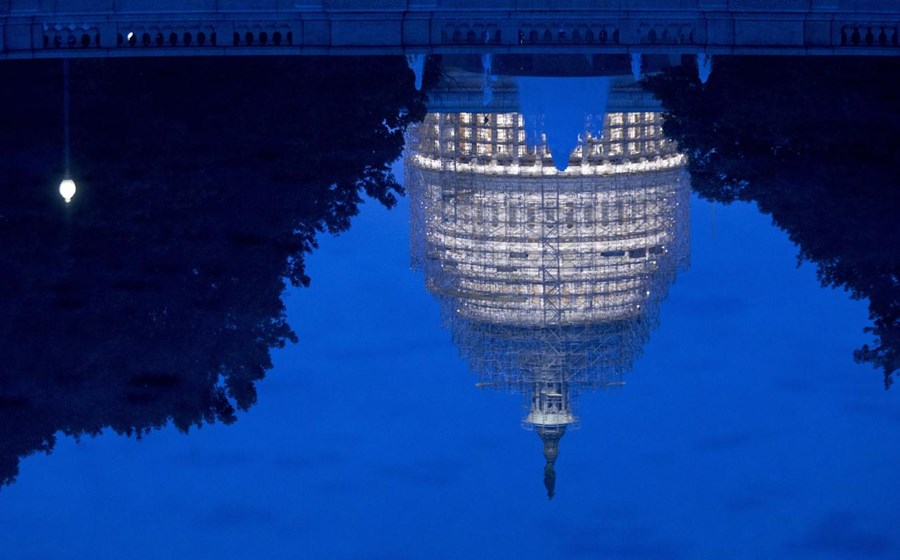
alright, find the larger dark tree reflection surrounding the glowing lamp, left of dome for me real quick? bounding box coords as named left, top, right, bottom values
left=0, top=57, right=434, bottom=483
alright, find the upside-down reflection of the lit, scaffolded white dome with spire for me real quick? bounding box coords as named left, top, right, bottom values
left=406, top=73, right=689, bottom=498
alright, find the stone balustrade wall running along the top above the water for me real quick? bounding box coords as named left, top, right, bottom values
left=0, top=0, right=900, bottom=59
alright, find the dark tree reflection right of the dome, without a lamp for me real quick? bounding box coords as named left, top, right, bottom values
left=646, top=57, right=900, bottom=388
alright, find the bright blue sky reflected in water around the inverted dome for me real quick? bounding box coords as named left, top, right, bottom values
left=0, top=150, right=900, bottom=560
